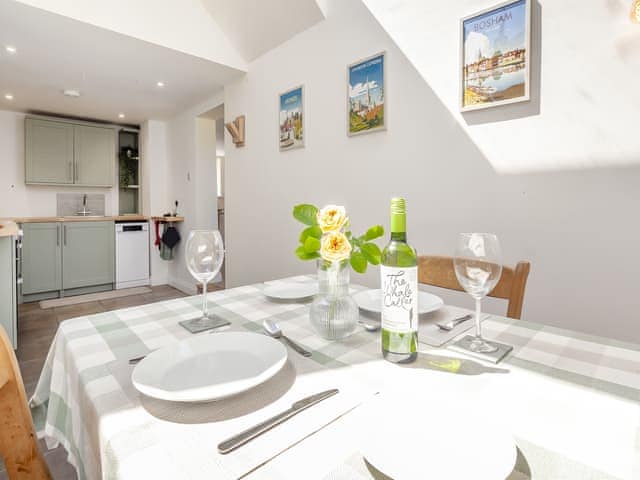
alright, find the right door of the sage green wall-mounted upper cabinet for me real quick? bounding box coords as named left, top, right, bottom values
left=74, top=125, right=116, bottom=187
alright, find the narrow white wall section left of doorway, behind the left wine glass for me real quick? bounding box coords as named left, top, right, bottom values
left=164, top=91, right=223, bottom=293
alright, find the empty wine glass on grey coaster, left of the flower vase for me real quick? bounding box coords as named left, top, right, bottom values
left=181, top=230, right=226, bottom=333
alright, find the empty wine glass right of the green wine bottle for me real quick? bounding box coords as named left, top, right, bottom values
left=453, top=233, right=502, bottom=353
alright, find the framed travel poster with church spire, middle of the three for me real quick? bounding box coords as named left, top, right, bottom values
left=347, top=52, right=387, bottom=136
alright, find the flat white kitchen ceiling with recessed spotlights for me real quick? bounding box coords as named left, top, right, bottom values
left=0, top=0, right=243, bottom=123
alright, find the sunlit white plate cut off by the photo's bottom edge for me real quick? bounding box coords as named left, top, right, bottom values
left=360, top=394, right=516, bottom=480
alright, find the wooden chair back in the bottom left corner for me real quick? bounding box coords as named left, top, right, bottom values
left=0, top=326, right=51, bottom=480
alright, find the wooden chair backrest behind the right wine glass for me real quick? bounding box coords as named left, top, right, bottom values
left=418, top=255, right=531, bottom=319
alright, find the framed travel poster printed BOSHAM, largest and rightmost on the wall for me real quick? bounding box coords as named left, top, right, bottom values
left=460, top=0, right=531, bottom=112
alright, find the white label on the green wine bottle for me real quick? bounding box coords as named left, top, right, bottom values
left=380, top=265, right=418, bottom=333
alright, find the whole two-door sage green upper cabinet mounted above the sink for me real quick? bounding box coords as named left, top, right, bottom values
left=25, top=117, right=117, bottom=187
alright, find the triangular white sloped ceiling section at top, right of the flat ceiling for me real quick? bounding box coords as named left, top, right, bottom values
left=202, top=0, right=324, bottom=62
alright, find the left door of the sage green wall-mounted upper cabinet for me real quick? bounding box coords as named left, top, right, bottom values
left=25, top=118, right=74, bottom=184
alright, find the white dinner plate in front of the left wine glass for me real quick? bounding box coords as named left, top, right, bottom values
left=131, top=332, right=287, bottom=402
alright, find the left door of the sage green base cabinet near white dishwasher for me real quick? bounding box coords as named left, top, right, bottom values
left=22, top=223, right=62, bottom=295
